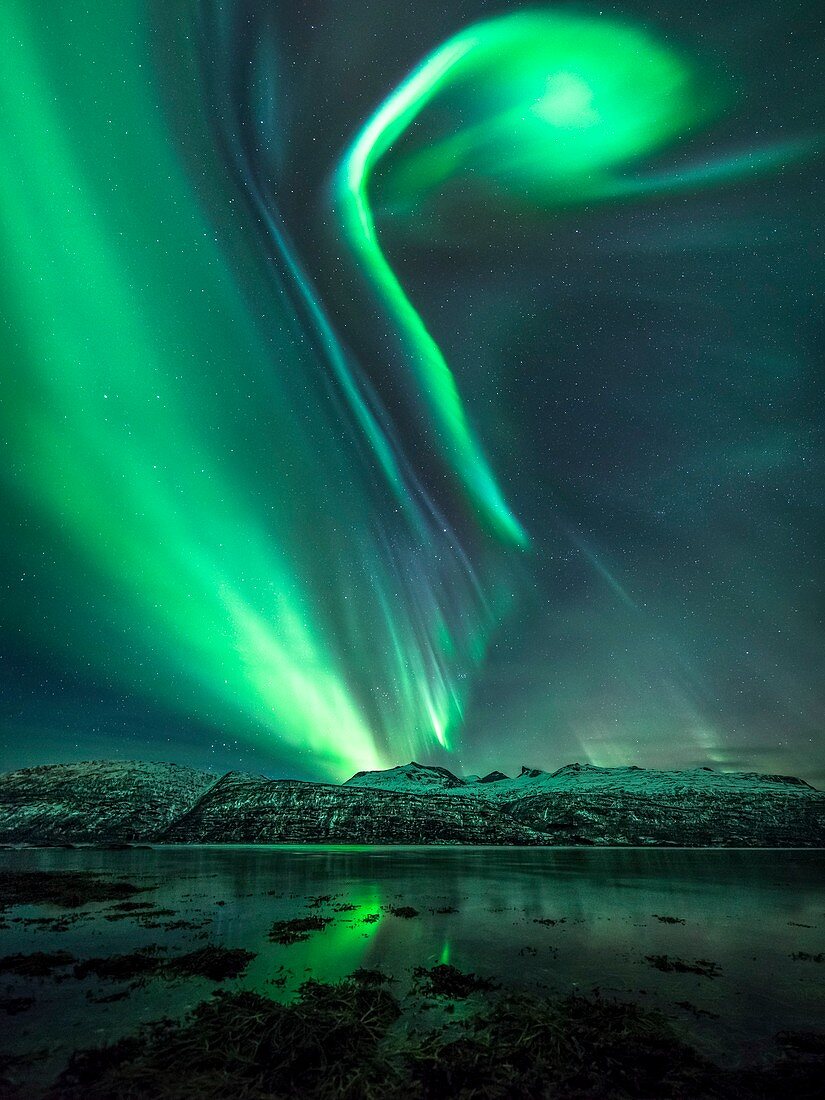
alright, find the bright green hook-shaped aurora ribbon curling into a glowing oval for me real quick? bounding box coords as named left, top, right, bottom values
left=338, top=13, right=721, bottom=545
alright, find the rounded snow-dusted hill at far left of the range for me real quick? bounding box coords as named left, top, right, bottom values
left=0, top=760, right=218, bottom=844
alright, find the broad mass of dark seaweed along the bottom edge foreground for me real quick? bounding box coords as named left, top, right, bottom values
left=47, top=971, right=825, bottom=1100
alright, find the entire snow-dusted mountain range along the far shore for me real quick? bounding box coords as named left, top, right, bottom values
left=0, top=761, right=825, bottom=847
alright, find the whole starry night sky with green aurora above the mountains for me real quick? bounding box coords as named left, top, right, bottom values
left=0, top=0, right=825, bottom=782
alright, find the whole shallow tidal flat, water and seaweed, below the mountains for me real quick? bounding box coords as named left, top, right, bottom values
left=0, top=846, right=825, bottom=1098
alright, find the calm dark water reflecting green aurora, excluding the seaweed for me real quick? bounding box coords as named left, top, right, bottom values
left=0, top=846, right=825, bottom=1081
